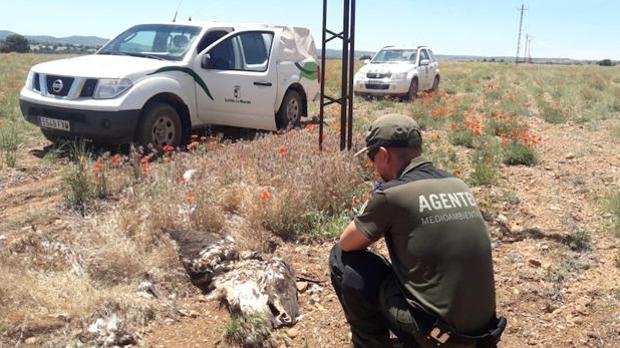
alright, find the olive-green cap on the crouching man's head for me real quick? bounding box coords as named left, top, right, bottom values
left=355, top=114, right=422, bottom=156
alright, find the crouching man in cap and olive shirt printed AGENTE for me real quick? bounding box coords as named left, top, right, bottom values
left=329, top=114, right=506, bottom=348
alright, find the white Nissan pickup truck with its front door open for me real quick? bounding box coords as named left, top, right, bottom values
left=20, top=22, right=320, bottom=147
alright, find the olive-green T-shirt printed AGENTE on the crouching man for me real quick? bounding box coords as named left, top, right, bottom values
left=354, top=157, right=495, bottom=335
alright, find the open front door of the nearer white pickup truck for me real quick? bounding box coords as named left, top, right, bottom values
left=194, top=30, right=277, bottom=129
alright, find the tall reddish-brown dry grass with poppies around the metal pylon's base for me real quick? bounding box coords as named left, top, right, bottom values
left=139, top=127, right=363, bottom=238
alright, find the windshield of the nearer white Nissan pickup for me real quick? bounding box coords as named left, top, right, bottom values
left=97, top=24, right=200, bottom=60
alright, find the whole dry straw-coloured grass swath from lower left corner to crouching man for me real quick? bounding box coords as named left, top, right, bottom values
left=0, top=128, right=366, bottom=339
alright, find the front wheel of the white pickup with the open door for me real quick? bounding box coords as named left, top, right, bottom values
left=136, top=102, right=183, bottom=149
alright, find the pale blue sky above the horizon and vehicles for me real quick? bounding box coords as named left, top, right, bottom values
left=0, top=0, right=620, bottom=60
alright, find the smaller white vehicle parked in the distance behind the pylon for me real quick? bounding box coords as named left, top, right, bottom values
left=353, top=46, right=440, bottom=100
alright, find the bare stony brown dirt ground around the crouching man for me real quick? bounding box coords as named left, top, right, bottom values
left=143, top=118, right=620, bottom=347
